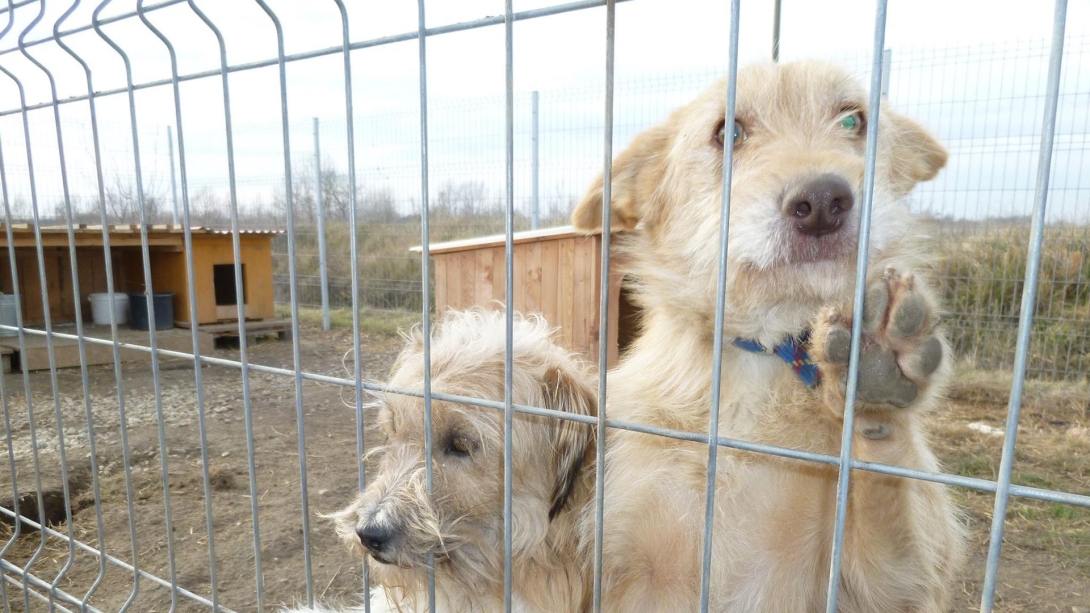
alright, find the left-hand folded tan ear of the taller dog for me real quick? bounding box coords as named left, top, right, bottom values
left=571, top=123, right=671, bottom=232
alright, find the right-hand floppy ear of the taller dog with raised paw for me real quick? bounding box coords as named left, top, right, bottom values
left=881, top=108, right=947, bottom=194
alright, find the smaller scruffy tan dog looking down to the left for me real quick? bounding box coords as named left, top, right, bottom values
left=281, top=310, right=597, bottom=613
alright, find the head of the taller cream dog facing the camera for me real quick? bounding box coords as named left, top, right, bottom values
left=572, top=61, right=946, bottom=335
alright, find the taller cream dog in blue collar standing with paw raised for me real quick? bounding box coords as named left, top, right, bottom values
left=571, top=62, right=962, bottom=613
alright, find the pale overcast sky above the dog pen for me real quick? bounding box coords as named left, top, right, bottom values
left=0, top=0, right=1090, bottom=220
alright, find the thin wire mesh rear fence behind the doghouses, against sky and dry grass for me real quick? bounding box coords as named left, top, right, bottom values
left=0, top=31, right=1090, bottom=381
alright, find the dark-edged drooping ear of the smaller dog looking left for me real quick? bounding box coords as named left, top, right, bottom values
left=542, top=365, right=598, bottom=519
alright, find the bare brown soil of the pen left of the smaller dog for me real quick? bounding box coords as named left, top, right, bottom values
left=0, top=328, right=400, bottom=613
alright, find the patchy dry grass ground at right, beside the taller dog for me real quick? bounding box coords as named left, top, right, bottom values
left=931, top=369, right=1090, bottom=613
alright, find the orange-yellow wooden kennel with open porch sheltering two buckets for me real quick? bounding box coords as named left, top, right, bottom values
left=0, top=224, right=280, bottom=370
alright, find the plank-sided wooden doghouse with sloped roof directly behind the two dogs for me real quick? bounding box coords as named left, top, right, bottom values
left=412, top=226, right=632, bottom=368
